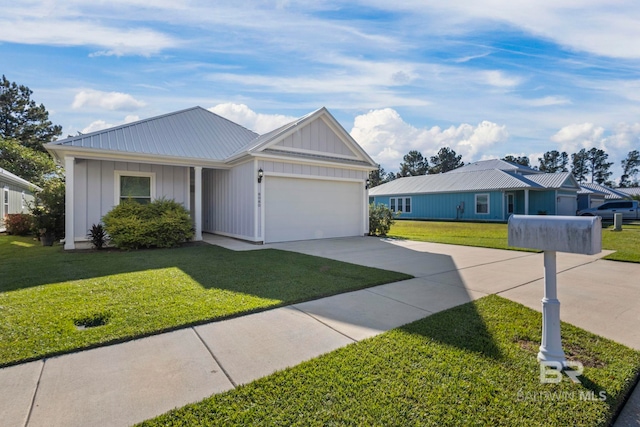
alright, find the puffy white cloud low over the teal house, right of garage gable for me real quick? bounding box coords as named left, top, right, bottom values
left=351, top=108, right=509, bottom=171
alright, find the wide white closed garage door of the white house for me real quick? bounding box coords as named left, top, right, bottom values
left=264, top=176, right=364, bottom=243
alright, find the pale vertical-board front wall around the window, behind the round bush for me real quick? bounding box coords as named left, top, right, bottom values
left=73, top=159, right=189, bottom=241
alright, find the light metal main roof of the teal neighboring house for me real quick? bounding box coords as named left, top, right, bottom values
left=369, top=169, right=543, bottom=196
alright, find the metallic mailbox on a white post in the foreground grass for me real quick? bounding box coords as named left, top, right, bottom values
left=508, top=215, right=602, bottom=365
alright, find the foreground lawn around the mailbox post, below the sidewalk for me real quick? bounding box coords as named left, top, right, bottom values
left=142, top=296, right=640, bottom=426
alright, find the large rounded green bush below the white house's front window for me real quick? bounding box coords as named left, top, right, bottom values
left=102, top=199, right=193, bottom=249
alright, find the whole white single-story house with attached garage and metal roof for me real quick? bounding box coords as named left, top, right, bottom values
left=46, top=107, right=377, bottom=249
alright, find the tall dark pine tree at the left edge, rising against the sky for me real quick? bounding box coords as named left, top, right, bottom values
left=0, top=75, right=62, bottom=153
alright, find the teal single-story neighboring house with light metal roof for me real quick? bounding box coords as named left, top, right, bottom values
left=369, top=159, right=580, bottom=221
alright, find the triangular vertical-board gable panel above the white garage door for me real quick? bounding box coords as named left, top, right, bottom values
left=272, top=119, right=356, bottom=159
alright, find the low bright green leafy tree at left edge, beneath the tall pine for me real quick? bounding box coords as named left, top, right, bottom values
left=0, top=137, right=60, bottom=187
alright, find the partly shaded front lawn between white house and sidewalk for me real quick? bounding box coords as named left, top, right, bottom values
left=0, top=235, right=410, bottom=366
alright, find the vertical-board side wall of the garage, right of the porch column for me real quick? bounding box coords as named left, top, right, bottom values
left=202, top=161, right=257, bottom=241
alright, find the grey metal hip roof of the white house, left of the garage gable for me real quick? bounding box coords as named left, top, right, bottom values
left=48, top=107, right=258, bottom=160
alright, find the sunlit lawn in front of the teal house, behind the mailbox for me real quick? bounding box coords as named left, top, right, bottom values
left=389, top=220, right=640, bottom=262
